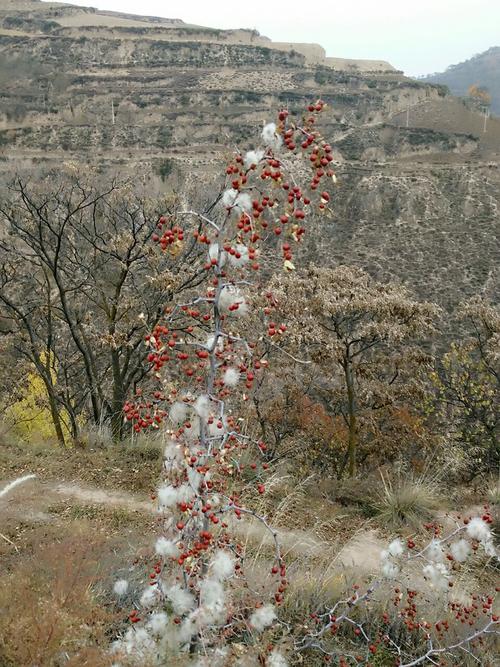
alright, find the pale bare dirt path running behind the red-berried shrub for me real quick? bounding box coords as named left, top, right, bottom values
left=0, top=479, right=384, bottom=572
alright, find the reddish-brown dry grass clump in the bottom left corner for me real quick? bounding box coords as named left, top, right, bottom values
left=0, top=529, right=117, bottom=667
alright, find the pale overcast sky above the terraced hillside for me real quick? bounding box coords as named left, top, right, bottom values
left=48, top=0, right=500, bottom=76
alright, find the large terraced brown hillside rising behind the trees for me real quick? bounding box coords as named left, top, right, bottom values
left=0, top=0, right=500, bottom=305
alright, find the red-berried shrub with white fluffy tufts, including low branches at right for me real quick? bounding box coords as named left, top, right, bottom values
left=112, top=101, right=498, bottom=667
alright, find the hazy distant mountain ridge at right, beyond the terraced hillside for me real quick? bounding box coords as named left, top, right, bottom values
left=423, top=46, right=500, bottom=115
